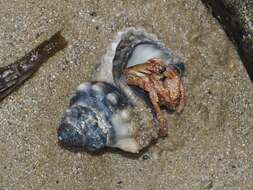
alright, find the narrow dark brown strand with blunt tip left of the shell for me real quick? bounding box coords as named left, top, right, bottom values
left=0, top=31, right=67, bottom=101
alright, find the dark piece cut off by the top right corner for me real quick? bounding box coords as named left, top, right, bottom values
left=202, top=0, right=253, bottom=82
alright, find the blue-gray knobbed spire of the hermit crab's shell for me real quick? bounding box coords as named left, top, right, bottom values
left=58, top=82, right=132, bottom=151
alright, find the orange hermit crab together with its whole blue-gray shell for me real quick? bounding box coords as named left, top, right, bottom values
left=58, top=28, right=186, bottom=153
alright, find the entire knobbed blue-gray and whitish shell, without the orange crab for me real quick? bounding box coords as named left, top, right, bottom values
left=58, top=28, right=184, bottom=153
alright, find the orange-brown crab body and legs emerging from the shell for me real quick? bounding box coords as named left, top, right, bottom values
left=124, top=58, right=186, bottom=136
